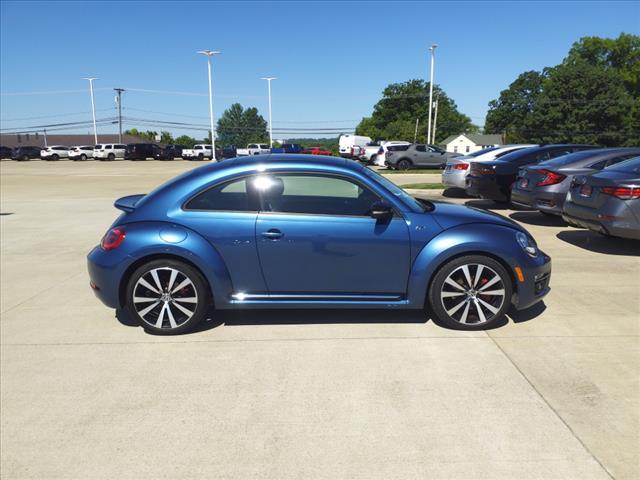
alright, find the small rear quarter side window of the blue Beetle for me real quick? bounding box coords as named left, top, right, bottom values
left=185, top=178, right=259, bottom=212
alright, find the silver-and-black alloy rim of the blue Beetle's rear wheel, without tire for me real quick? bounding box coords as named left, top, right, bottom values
left=132, top=267, right=198, bottom=330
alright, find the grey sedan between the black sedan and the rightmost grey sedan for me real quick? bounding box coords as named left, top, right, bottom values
left=511, top=148, right=640, bottom=215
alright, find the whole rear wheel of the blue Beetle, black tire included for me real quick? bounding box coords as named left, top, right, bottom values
left=126, top=259, right=211, bottom=335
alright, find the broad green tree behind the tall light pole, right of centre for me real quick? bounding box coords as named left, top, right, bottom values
left=356, top=80, right=478, bottom=143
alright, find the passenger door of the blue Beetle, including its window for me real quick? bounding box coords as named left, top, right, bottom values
left=256, top=172, right=410, bottom=298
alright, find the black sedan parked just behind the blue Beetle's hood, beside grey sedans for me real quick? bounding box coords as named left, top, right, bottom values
left=466, top=144, right=598, bottom=202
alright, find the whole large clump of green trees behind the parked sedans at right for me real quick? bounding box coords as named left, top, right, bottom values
left=485, top=33, right=640, bottom=146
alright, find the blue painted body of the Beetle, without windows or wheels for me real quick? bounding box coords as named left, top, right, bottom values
left=88, top=154, right=550, bottom=309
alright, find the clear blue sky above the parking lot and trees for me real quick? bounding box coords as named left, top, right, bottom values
left=0, top=1, right=640, bottom=138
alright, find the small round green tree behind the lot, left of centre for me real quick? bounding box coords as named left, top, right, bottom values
left=216, top=103, right=269, bottom=147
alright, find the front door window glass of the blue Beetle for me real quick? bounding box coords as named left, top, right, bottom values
left=253, top=174, right=380, bottom=216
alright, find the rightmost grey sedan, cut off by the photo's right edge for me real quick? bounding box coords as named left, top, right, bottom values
left=562, top=157, right=640, bottom=240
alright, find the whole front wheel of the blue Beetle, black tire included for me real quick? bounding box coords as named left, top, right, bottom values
left=428, top=255, right=513, bottom=330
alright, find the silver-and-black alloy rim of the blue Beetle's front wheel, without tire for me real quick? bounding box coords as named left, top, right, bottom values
left=440, top=263, right=506, bottom=325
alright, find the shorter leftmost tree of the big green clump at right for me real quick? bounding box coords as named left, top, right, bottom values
left=484, top=71, right=548, bottom=143
